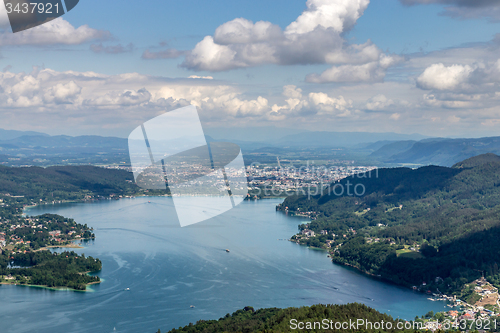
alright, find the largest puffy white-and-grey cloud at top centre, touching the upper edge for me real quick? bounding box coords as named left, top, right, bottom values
left=181, top=0, right=402, bottom=83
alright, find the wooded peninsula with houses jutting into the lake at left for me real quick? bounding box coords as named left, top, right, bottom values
left=0, top=193, right=102, bottom=291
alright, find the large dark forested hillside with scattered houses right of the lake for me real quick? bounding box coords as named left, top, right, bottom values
left=278, top=154, right=500, bottom=292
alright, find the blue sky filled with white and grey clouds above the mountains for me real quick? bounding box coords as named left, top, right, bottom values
left=0, top=0, right=500, bottom=137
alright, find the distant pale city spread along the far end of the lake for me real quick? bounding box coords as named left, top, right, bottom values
left=118, top=157, right=377, bottom=199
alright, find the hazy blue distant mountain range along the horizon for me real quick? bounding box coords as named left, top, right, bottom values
left=0, top=127, right=500, bottom=166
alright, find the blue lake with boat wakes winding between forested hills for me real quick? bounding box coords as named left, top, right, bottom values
left=0, top=197, right=449, bottom=333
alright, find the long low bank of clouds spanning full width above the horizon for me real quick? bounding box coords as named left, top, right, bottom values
left=0, top=63, right=500, bottom=135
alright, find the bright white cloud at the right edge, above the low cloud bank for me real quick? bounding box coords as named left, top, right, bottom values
left=404, top=35, right=500, bottom=113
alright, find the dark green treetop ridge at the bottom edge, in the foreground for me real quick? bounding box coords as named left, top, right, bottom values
left=170, top=303, right=413, bottom=333
